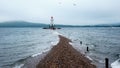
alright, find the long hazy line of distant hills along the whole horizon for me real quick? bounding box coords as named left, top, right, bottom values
left=0, top=21, right=120, bottom=27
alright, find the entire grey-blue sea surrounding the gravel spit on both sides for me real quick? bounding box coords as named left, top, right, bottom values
left=0, top=27, right=120, bottom=68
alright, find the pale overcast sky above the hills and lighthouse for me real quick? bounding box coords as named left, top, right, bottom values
left=0, top=0, right=120, bottom=25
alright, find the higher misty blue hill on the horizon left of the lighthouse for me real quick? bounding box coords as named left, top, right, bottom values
left=0, top=21, right=48, bottom=27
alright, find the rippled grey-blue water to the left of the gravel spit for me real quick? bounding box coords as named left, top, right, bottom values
left=0, top=28, right=56, bottom=68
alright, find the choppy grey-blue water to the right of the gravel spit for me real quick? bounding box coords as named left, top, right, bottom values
left=57, top=27, right=120, bottom=68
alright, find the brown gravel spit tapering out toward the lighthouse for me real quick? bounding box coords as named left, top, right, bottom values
left=36, top=35, right=96, bottom=68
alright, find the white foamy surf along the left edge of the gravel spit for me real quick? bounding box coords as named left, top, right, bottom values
left=13, top=32, right=59, bottom=68
